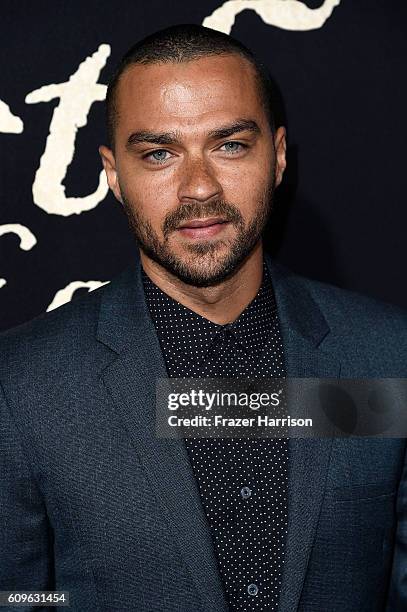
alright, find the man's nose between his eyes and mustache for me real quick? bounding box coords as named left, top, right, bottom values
left=178, top=157, right=222, bottom=202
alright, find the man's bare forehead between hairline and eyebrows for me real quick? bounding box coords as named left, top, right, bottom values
left=116, top=55, right=266, bottom=132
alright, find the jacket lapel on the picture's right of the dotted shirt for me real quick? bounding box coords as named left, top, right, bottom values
left=266, top=256, right=340, bottom=612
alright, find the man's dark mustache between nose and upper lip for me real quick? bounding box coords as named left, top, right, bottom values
left=163, top=199, right=243, bottom=238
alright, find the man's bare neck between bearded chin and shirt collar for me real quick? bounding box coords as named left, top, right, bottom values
left=140, top=241, right=263, bottom=325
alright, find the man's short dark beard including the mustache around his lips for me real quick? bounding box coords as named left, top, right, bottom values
left=121, top=168, right=275, bottom=287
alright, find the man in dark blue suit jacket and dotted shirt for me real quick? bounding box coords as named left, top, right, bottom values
left=0, top=25, right=407, bottom=612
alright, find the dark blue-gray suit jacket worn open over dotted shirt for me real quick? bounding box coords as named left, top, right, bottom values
left=0, top=251, right=407, bottom=612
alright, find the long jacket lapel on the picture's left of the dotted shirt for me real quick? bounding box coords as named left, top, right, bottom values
left=98, top=261, right=227, bottom=612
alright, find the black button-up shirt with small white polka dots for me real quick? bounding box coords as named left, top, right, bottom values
left=142, top=262, right=288, bottom=611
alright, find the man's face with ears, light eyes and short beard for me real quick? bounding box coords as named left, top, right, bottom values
left=100, top=55, right=285, bottom=287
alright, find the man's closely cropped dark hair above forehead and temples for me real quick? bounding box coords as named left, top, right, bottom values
left=106, top=24, right=275, bottom=148
